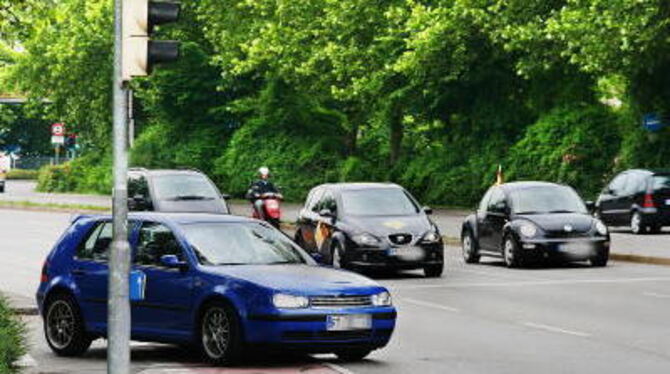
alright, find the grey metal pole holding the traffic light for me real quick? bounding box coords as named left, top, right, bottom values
left=107, top=0, right=130, bottom=374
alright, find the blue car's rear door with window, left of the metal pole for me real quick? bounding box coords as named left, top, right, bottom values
left=71, top=221, right=112, bottom=331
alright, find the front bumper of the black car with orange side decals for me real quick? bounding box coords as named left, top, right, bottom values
left=345, top=242, right=444, bottom=270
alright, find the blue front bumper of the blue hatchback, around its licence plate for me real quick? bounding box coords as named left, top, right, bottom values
left=244, top=307, right=397, bottom=353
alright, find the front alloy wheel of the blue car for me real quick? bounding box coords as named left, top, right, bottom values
left=202, top=307, right=231, bottom=360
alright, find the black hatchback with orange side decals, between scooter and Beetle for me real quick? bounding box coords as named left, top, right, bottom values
left=295, top=183, right=444, bottom=277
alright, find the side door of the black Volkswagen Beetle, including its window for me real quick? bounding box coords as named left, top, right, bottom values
left=479, top=186, right=509, bottom=251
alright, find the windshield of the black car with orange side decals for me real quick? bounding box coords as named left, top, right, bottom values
left=342, top=188, right=419, bottom=216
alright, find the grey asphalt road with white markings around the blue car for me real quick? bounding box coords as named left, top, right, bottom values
left=0, top=210, right=670, bottom=374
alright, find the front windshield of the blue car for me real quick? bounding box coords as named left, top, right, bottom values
left=183, top=223, right=311, bottom=265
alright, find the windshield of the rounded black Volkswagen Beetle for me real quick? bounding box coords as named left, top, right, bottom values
left=511, top=186, right=587, bottom=214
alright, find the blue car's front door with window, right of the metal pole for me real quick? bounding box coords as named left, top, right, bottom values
left=133, top=221, right=194, bottom=337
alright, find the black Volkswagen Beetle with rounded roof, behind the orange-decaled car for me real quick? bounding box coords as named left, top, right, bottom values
left=461, top=182, right=610, bottom=267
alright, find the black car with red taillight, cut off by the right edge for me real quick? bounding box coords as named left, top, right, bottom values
left=595, top=169, right=670, bottom=234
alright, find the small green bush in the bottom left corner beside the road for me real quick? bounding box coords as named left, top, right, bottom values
left=0, top=297, right=26, bottom=373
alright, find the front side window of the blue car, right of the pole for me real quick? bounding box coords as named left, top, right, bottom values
left=134, top=222, right=185, bottom=266
